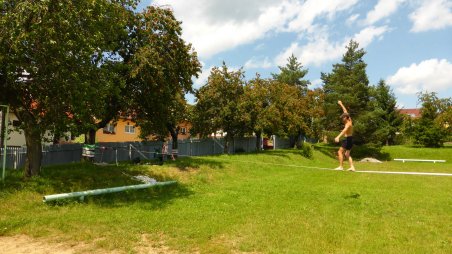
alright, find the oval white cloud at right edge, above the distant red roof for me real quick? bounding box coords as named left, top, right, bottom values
left=387, top=59, right=452, bottom=94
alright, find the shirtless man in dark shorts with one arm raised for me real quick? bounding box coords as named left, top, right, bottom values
left=334, top=101, right=355, bottom=171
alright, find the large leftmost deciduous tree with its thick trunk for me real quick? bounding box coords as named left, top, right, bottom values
left=0, top=0, right=135, bottom=177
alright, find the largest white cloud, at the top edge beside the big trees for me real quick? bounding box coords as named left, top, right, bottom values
left=153, top=0, right=358, bottom=59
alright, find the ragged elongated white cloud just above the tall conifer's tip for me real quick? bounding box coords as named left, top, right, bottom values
left=275, top=26, right=389, bottom=66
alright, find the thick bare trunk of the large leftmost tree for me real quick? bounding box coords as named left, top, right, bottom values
left=24, top=127, right=42, bottom=178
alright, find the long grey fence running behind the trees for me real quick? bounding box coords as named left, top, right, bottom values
left=0, top=137, right=289, bottom=169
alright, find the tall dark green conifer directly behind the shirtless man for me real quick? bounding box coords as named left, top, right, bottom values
left=321, top=40, right=387, bottom=156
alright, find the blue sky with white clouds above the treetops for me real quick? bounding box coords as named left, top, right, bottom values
left=139, top=0, right=452, bottom=108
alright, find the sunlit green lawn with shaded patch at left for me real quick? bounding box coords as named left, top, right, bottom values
left=0, top=146, right=452, bottom=253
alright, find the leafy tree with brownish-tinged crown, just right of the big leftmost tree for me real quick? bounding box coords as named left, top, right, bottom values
left=129, top=6, right=201, bottom=149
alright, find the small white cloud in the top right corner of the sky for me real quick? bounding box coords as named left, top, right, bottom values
left=410, top=0, right=452, bottom=32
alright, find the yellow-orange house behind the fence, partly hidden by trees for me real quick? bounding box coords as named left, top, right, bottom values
left=96, top=117, right=192, bottom=142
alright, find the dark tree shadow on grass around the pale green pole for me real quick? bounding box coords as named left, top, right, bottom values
left=0, top=163, right=192, bottom=209
